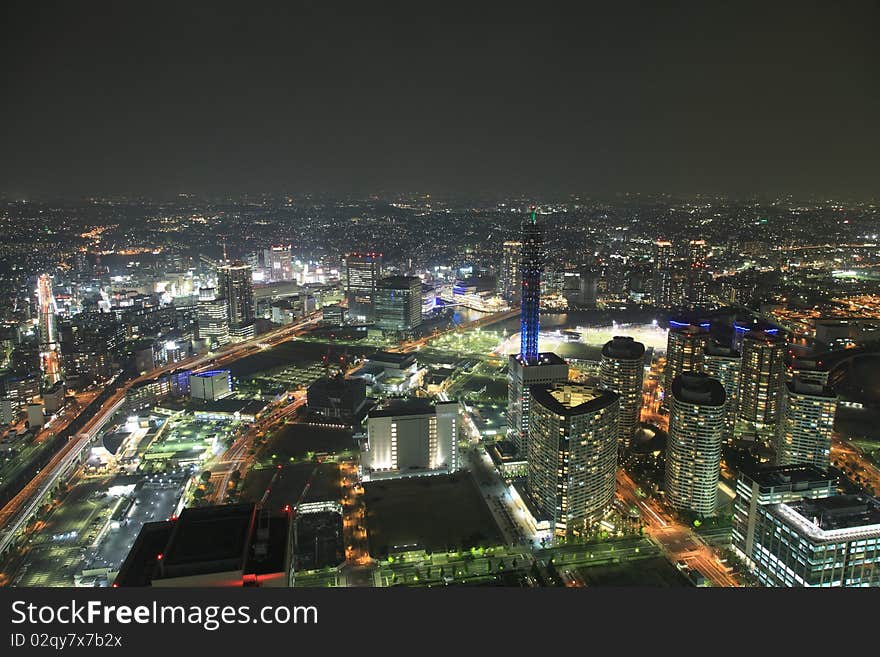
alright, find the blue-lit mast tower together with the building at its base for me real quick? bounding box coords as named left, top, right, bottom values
left=507, top=207, right=568, bottom=455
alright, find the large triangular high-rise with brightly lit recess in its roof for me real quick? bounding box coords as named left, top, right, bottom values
left=528, top=383, right=619, bottom=535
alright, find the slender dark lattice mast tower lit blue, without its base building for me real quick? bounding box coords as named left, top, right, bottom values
left=519, top=206, right=544, bottom=364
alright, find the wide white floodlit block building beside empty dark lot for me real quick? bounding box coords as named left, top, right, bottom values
left=361, top=399, right=461, bottom=481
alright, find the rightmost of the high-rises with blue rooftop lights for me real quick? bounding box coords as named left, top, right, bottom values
left=737, top=331, right=785, bottom=428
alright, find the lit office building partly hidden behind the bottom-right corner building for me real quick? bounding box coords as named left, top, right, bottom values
left=732, top=465, right=837, bottom=567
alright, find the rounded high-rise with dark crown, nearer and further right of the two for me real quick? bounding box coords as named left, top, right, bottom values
left=665, top=372, right=725, bottom=516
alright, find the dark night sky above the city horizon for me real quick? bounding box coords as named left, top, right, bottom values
left=0, top=0, right=880, bottom=198
